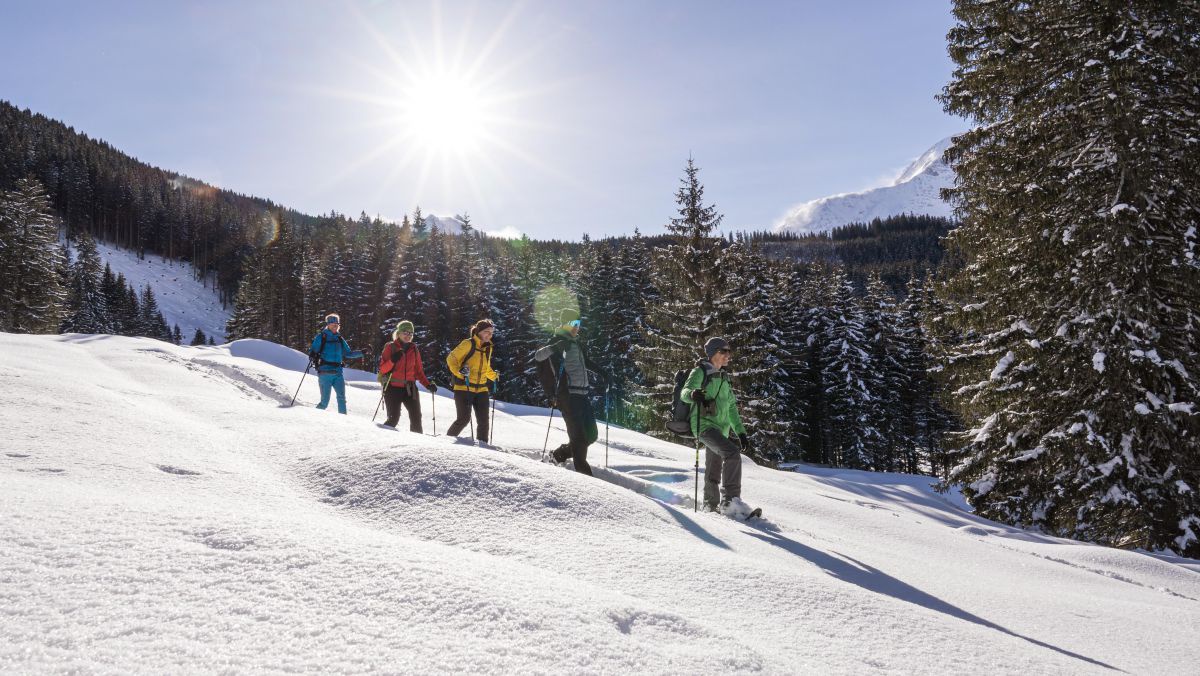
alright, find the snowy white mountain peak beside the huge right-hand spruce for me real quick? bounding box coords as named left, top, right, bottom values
left=775, top=138, right=954, bottom=234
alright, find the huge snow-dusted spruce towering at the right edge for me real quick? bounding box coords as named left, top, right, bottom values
left=942, top=0, right=1200, bottom=556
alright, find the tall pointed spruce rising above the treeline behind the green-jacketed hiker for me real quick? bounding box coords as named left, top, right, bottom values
left=635, top=157, right=724, bottom=435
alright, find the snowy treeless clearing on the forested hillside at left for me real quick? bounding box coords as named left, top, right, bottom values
left=96, top=241, right=233, bottom=342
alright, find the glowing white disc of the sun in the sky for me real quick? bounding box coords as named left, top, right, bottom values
left=397, top=72, right=490, bottom=157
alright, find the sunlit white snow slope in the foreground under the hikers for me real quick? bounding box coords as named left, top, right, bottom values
left=0, top=334, right=1200, bottom=674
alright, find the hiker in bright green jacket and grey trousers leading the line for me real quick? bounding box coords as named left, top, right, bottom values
left=679, top=337, right=750, bottom=513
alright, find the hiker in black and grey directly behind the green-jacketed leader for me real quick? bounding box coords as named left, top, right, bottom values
left=534, top=310, right=608, bottom=477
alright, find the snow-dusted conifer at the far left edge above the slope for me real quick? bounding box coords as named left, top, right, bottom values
left=0, top=179, right=67, bottom=334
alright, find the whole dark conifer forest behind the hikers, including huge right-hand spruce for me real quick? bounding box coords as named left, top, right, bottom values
left=0, top=0, right=1200, bottom=556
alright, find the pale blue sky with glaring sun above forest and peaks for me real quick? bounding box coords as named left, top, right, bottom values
left=0, top=0, right=965, bottom=239
